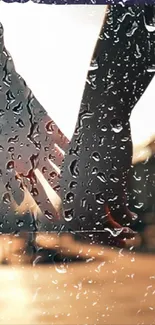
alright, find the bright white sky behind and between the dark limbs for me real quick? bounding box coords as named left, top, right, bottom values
left=0, top=1, right=155, bottom=144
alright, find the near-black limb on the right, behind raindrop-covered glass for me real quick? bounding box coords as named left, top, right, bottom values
left=60, top=5, right=155, bottom=243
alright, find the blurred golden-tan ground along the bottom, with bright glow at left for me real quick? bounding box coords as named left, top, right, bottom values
left=0, top=235, right=155, bottom=325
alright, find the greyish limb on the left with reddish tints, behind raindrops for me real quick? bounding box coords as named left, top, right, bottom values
left=0, top=24, right=68, bottom=232
